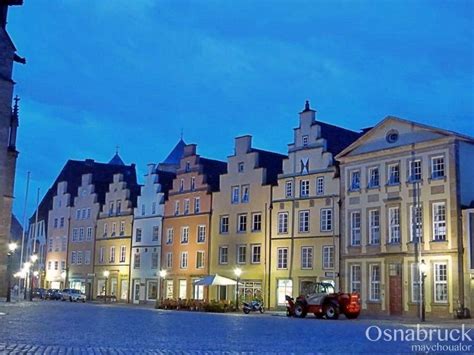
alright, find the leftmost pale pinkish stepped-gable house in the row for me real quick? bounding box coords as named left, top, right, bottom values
left=45, top=181, right=71, bottom=289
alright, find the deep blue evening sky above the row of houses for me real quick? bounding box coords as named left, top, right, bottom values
left=8, top=0, right=474, bottom=221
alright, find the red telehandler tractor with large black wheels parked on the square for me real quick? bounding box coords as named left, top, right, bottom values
left=286, top=282, right=360, bottom=319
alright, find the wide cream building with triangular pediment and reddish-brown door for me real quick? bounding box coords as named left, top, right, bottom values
left=336, top=117, right=474, bottom=317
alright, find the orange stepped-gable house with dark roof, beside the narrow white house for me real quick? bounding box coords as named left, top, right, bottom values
left=162, top=144, right=227, bottom=299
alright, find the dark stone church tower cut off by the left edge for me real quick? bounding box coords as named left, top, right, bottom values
left=0, top=0, right=25, bottom=298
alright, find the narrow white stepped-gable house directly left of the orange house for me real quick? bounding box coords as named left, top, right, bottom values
left=130, top=164, right=175, bottom=303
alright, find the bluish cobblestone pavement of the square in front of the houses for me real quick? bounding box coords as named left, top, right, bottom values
left=0, top=301, right=474, bottom=354
